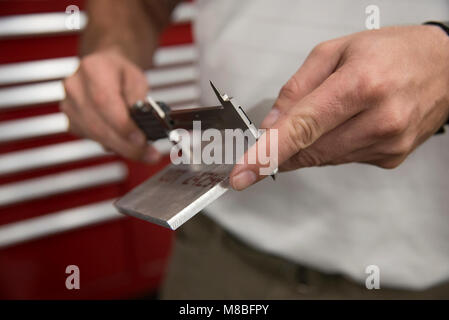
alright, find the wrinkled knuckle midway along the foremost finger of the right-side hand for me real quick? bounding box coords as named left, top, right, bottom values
left=288, top=115, right=319, bottom=151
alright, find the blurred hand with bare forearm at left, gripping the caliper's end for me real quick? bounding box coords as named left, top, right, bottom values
left=60, top=0, right=178, bottom=163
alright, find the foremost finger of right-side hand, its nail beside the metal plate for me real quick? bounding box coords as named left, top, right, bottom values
left=230, top=67, right=363, bottom=190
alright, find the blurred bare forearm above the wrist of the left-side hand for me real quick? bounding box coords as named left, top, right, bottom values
left=80, top=0, right=177, bottom=68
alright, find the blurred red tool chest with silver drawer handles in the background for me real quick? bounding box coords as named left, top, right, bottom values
left=0, top=0, right=198, bottom=299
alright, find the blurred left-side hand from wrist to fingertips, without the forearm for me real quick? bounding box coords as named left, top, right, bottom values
left=60, top=49, right=161, bottom=163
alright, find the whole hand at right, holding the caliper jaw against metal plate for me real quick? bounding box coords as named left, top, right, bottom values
left=230, top=26, right=449, bottom=190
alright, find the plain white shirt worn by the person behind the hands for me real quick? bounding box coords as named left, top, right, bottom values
left=195, top=0, right=449, bottom=289
